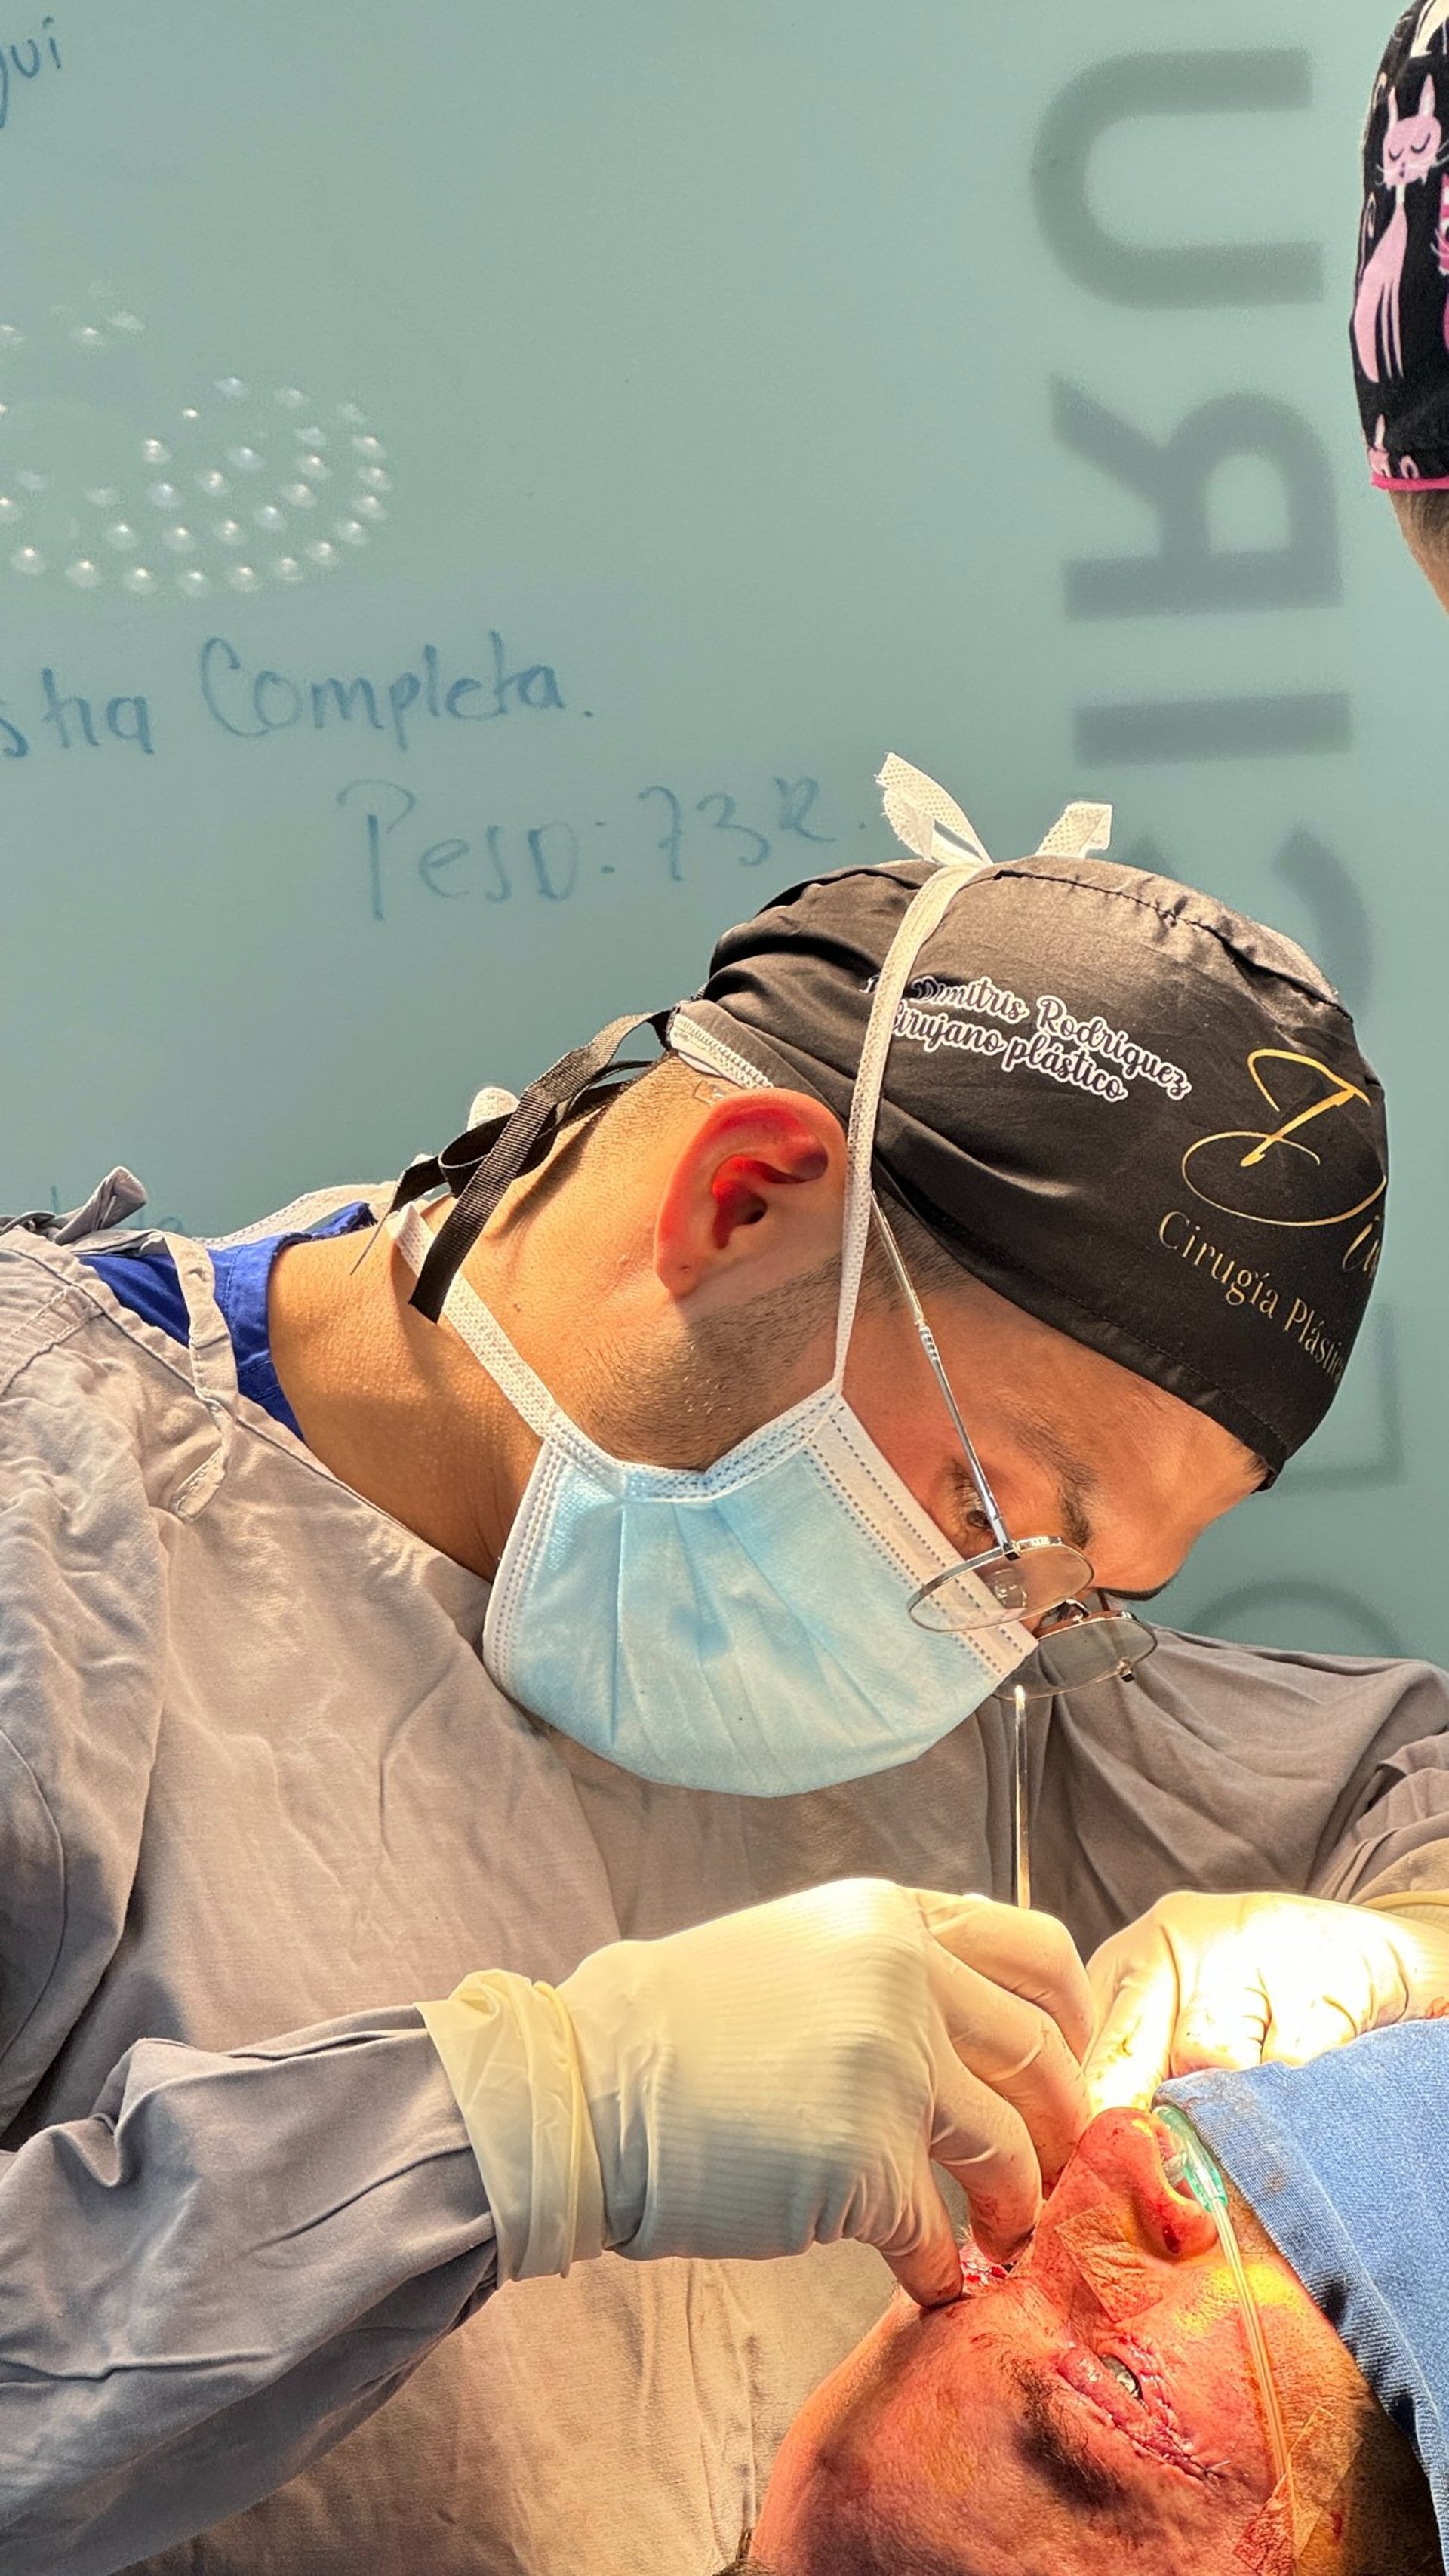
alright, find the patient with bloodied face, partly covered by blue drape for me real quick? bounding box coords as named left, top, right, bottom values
left=739, top=2025, right=1449, bottom=2576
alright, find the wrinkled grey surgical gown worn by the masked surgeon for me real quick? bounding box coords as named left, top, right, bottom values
left=0, top=1203, right=1449, bottom=2576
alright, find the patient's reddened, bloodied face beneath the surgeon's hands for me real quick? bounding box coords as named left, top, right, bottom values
left=749, top=2113, right=1441, bottom=2576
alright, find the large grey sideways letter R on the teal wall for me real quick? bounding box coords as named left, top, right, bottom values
left=1053, top=379, right=1341, bottom=618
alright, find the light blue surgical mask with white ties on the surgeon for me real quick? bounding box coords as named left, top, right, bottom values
left=389, top=845, right=1032, bottom=1798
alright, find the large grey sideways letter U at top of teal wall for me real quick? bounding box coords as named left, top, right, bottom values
left=1032, top=51, right=1323, bottom=312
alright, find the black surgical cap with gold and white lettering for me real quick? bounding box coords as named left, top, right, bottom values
left=674, top=860, right=1389, bottom=1476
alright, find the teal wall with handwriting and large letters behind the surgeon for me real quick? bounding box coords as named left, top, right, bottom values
left=0, top=0, right=1449, bottom=1659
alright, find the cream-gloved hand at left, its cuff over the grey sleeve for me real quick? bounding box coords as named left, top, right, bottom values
left=422, top=1880, right=1091, bottom=2306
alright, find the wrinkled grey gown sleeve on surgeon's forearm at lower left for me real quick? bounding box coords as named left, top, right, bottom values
left=0, top=2009, right=494, bottom=2576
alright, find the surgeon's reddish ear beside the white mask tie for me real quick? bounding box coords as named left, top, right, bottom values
left=654, top=1092, right=847, bottom=1309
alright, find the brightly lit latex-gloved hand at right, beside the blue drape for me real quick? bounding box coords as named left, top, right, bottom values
left=1086, top=1896, right=1449, bottom=2110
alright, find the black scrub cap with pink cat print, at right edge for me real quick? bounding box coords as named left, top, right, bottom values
left=1351, top=0, right=1449, bottom=492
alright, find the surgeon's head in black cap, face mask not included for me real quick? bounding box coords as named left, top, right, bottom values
left=414, top=858, right=1387, bottom=1595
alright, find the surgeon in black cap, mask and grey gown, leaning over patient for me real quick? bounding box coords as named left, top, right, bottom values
left=0, top=778, right=1449, bottom=2576
